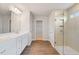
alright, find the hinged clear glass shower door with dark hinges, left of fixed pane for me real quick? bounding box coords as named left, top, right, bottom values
left=54, top=17, right=64, bottom=54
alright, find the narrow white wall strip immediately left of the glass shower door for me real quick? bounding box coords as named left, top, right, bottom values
left=48, top=11, right=55, bottom=46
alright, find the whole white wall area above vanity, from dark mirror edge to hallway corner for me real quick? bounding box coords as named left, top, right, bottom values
left=11, top=10, right=30, bottom=33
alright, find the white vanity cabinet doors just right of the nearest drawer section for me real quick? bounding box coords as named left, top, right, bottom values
left=16, top=34, right=28, bottom=55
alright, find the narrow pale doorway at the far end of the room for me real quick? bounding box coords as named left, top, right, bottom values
left=36, top=20, right=43, bottom=40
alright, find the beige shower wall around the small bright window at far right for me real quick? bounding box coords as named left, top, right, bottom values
left=65, top=4, right=79, bottom=52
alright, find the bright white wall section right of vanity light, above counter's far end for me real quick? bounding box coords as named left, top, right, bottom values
left=21, top=10, right=30, bottom=33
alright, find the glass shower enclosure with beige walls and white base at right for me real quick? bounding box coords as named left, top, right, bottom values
left=54, top=11, right=79, bottom=55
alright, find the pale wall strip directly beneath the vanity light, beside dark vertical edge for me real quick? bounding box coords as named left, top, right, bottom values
left=11, top=12, right=21, bottom=33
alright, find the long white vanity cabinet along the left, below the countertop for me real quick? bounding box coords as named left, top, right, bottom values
left=0, top=34, right=29, bottom=55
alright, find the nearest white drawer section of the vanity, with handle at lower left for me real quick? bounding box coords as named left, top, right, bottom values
left=0, top=39, right=16, bottom=55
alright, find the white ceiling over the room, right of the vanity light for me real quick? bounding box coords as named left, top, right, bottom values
left=24, top=3, right=73, bottom=16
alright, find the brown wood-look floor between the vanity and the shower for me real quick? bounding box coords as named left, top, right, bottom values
left=22, top=40, right=59, bottom=55
